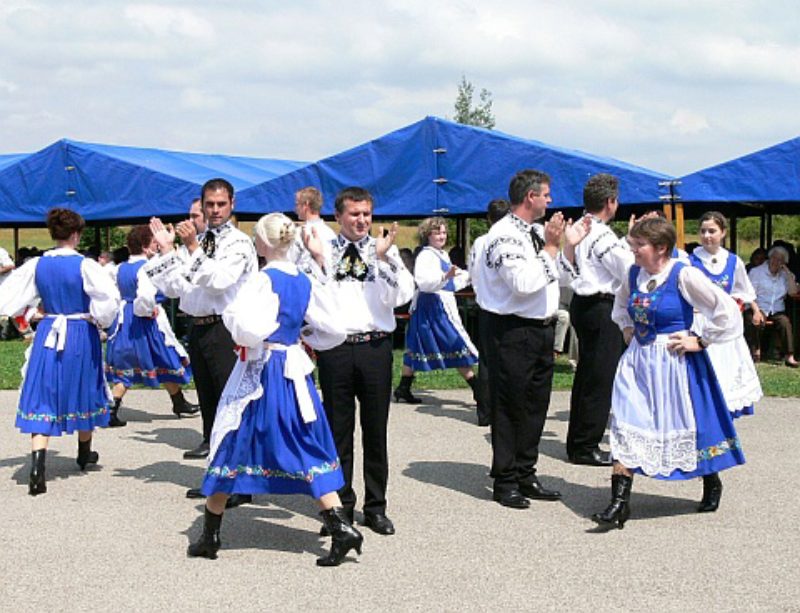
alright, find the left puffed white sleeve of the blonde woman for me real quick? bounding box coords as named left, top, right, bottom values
left=222, top=273, right=280, bottom=347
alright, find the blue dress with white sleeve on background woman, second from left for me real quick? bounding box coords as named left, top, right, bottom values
left=106, top=256, right=192, bottom=388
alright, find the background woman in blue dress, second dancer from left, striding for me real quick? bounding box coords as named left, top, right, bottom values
left=106, top=225, right=200, bottom=428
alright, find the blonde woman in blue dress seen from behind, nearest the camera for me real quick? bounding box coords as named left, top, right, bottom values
left=178, top=213, right=363, bottom=566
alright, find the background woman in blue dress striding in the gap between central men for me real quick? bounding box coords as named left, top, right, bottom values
left=394, top=217, right=478, bottom=404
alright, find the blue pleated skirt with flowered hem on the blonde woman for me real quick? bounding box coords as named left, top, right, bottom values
left=202, top=351, right=344, bottom=498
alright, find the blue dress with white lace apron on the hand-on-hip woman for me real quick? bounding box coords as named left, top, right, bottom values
left=610, top=261, right=745, bottom=480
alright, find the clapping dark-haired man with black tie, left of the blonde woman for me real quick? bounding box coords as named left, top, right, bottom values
left=144, top=179, right=257, bottom=474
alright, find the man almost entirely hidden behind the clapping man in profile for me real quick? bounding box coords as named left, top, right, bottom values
left=469, top=198, right=509, bottom=426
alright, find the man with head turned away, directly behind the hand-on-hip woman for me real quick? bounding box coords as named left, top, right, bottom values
left=567, top=173, right=634, bottom=466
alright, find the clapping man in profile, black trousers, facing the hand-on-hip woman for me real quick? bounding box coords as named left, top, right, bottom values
left=481, top=170, right=587, bottom=509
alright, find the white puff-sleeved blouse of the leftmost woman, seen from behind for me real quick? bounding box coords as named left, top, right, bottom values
left=0, top=247, right=120, bottom=328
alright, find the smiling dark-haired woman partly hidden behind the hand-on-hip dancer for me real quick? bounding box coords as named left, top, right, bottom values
left=689, top=211, right=764, bottom=418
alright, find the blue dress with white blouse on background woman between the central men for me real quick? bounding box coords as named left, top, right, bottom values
left=403, top=247, right=478, bottom=371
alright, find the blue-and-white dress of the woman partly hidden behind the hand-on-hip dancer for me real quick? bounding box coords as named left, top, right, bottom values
left=689, top=248, right=764, bottom=418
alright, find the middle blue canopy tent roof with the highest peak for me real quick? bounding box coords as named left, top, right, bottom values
left=237, top=117, right=669, bottom=218
